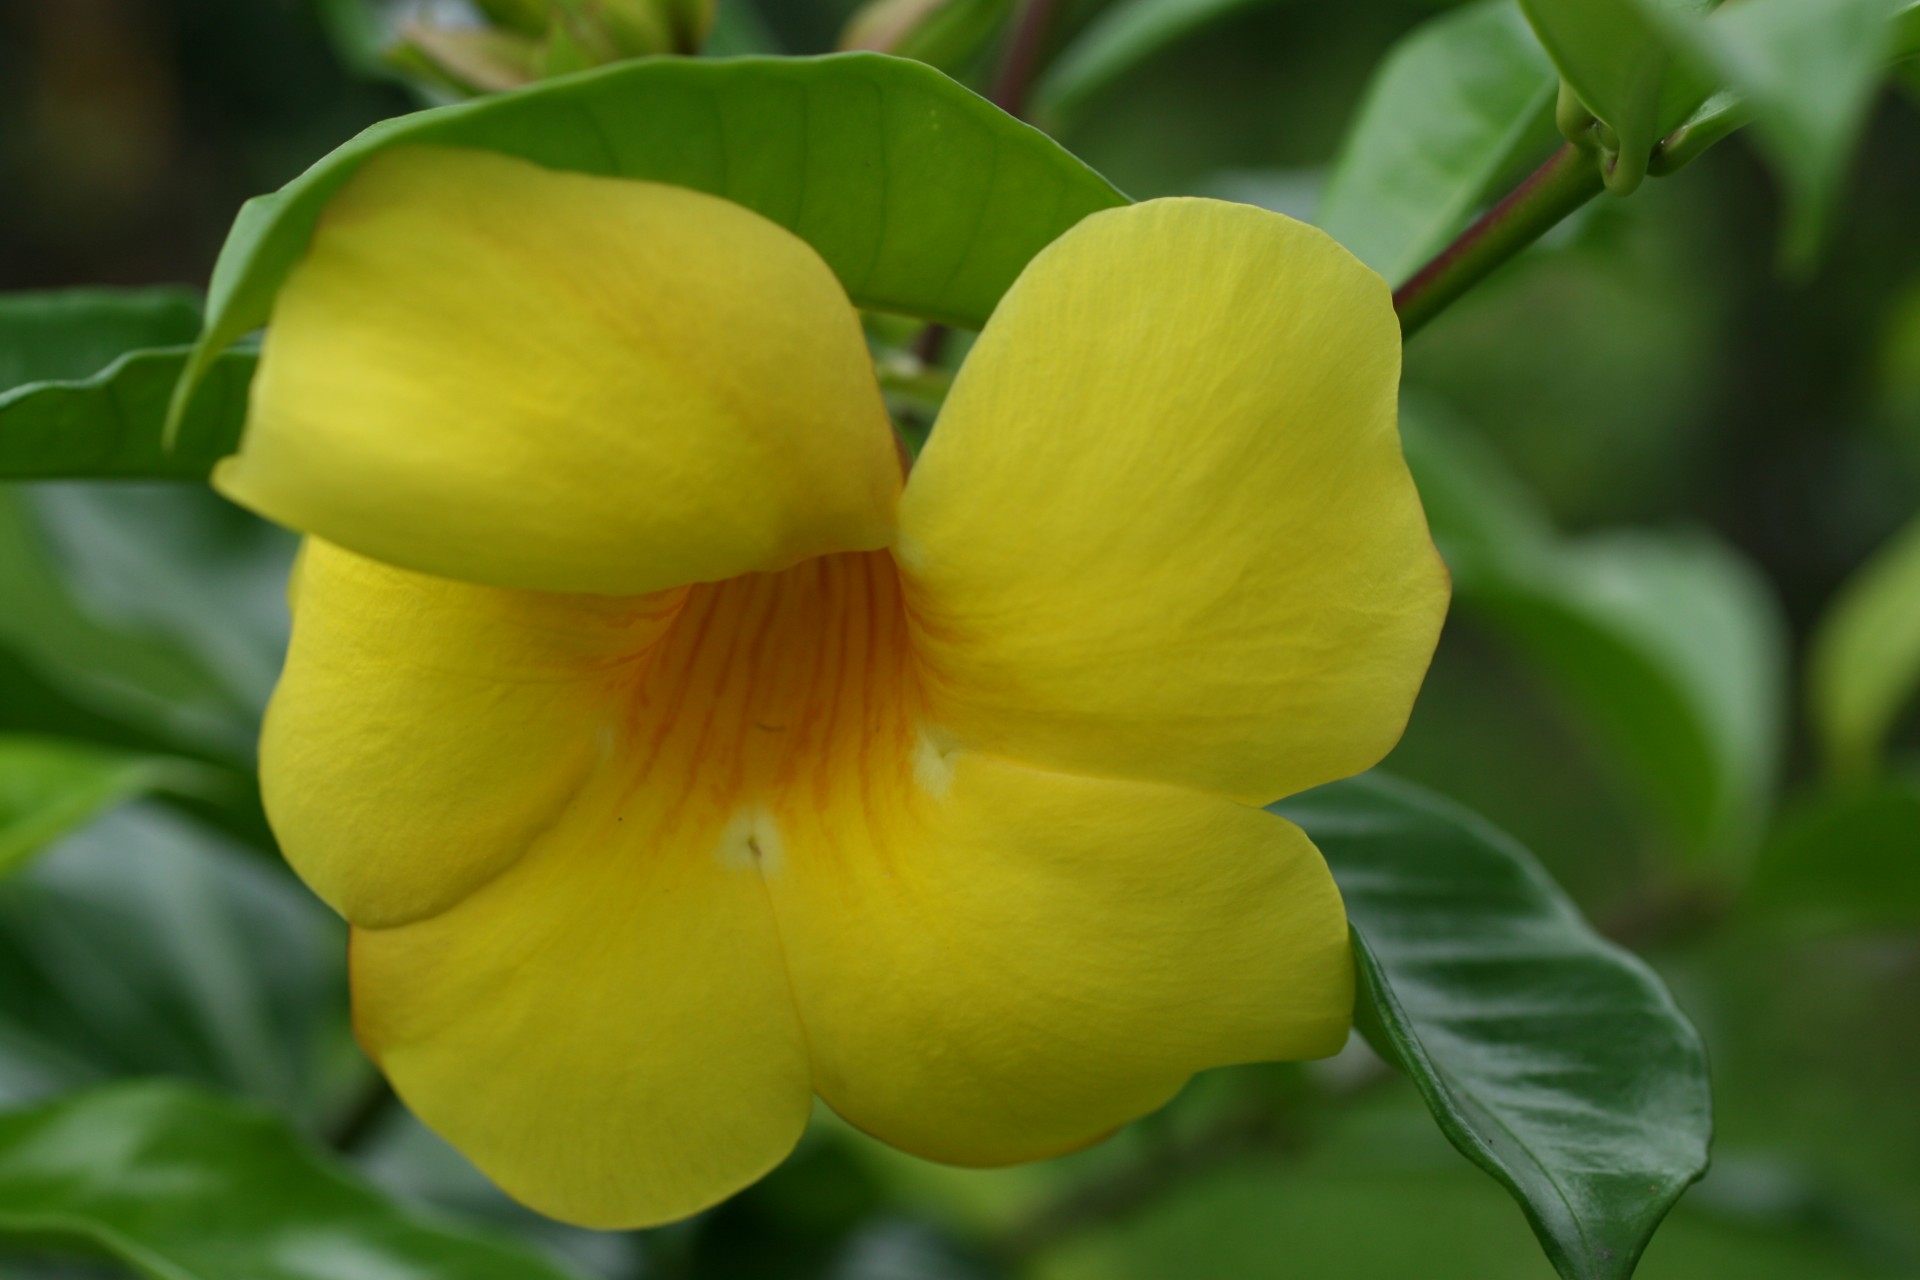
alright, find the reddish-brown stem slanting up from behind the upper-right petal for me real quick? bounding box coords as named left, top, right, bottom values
left=1394, top=142, right=1605, bottom=338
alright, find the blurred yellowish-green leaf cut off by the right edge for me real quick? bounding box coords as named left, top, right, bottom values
left=1807, top=520, right=1920, bottom=777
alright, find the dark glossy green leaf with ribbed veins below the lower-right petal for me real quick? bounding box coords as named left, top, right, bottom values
left=1277, top=779, right=1713, bottom=1280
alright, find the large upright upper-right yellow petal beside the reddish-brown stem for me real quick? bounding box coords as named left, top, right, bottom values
left=897, top=200, right=1448, bottom=804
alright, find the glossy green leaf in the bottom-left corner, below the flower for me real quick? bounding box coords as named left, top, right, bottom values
left=0, top=1082, right=568, bottom=1280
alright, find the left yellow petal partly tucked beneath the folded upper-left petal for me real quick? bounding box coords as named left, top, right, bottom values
left=261, top=539, right=684, bottom=925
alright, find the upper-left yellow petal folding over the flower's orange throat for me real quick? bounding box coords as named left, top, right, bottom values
left=215, top=148, right=900, bottom=593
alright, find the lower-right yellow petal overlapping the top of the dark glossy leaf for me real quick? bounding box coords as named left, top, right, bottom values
left=768, top=747, right=1354, bottom=1165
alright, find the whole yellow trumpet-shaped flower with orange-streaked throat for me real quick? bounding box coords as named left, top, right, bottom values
left=217, top=150, right=1446, bottom=1226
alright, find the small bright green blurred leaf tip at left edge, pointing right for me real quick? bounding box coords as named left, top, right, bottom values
left=0, top=733, right=217, bottom=877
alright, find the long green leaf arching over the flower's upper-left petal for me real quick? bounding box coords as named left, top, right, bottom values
left=175, top=54, right=1125, bottom=429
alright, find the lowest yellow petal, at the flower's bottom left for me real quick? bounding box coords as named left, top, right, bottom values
left=353, top=785, right=812, bottom=1228
